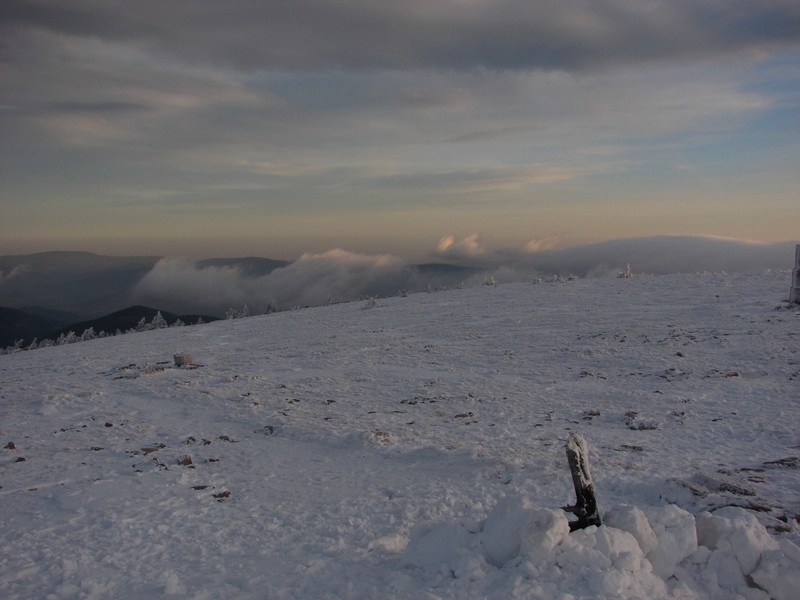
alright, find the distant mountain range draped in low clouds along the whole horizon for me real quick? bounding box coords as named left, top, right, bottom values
left=0, top=236, right=795, bottom=339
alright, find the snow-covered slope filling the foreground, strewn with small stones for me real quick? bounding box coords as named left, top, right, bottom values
left=0, top=272, right=800, bottom=599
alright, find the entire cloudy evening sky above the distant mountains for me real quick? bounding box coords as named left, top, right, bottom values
left=0, top=0, right=800, bottom=260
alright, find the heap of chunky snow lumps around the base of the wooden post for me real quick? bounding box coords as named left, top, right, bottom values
left=401, top=495, right=800, bottom=600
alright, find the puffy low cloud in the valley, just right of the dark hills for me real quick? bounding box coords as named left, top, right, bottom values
left=134, top=249, right=420, bottom=315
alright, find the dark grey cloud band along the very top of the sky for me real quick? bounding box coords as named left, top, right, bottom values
left=3, top=0, right=800, bottom=70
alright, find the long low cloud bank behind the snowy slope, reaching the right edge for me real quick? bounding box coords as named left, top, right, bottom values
left=134, top=235, right=794, bottom=315
